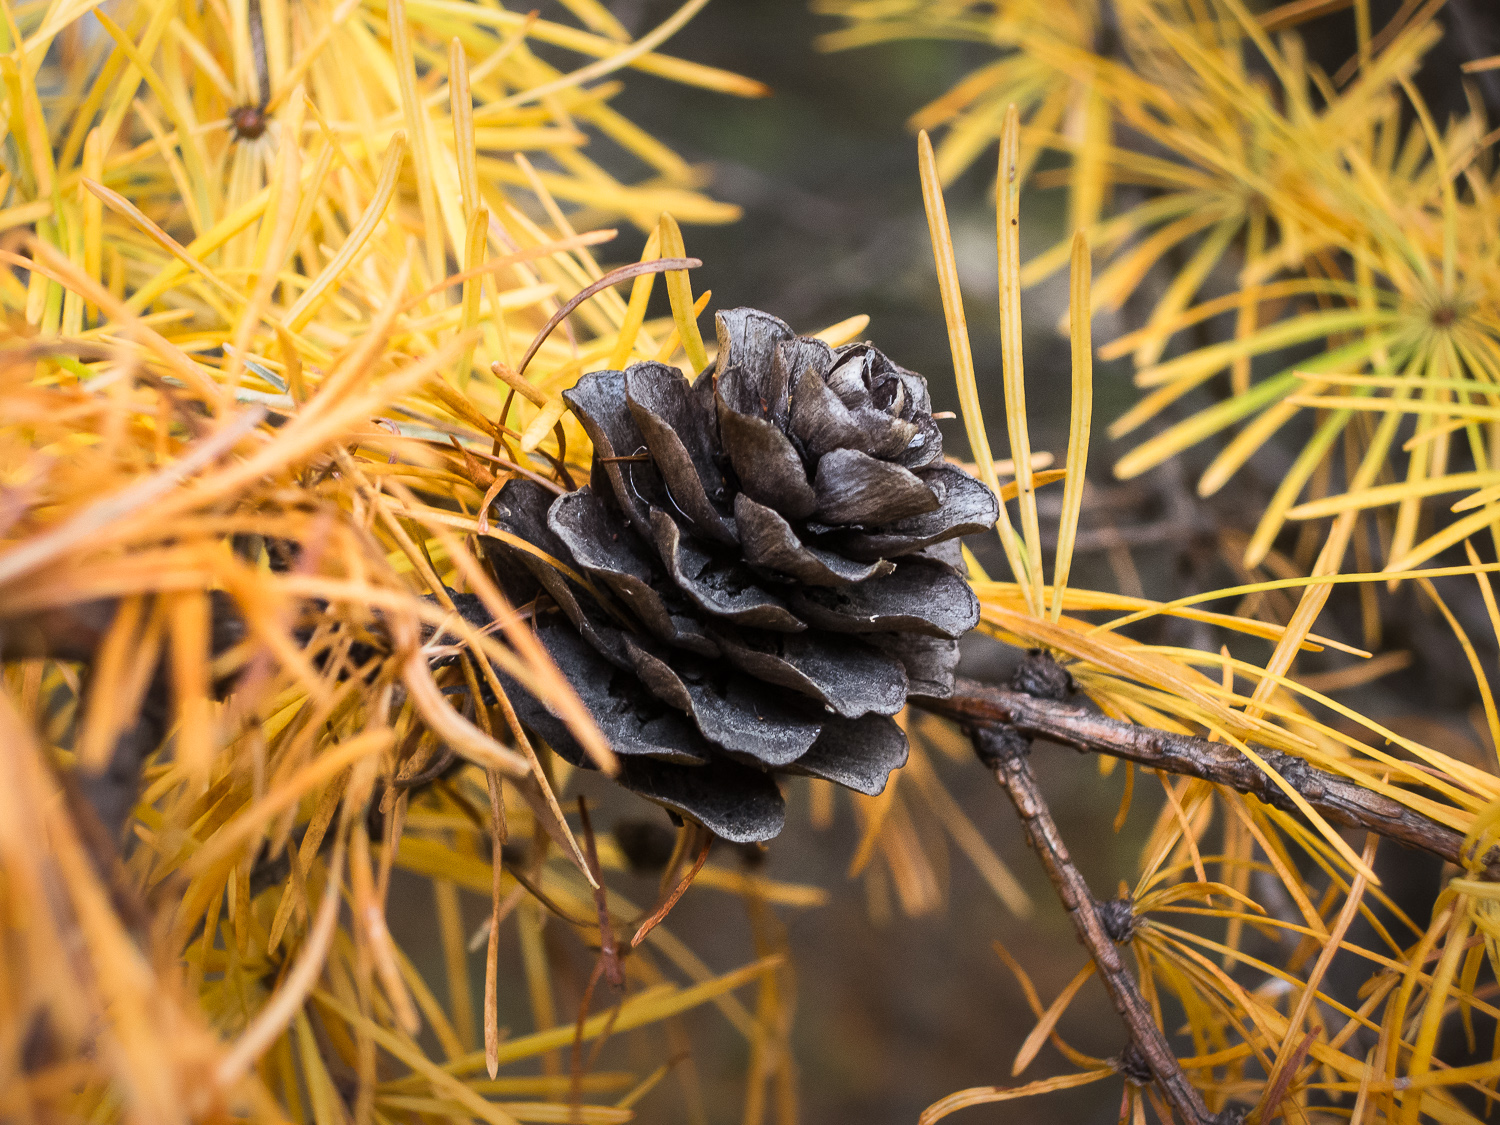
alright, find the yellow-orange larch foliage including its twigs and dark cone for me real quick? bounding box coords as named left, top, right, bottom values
left=0, top=0, right=1500, bottom=1125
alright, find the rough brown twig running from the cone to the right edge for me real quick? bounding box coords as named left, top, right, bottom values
left=921, top=680, right=1500, bottom=881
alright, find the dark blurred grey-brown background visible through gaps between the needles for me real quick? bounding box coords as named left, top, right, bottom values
left=392, top=0, right=1500, bottom=1125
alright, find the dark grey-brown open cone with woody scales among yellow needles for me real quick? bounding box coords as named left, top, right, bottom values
left=486, top=309, right=999, bottom=843
